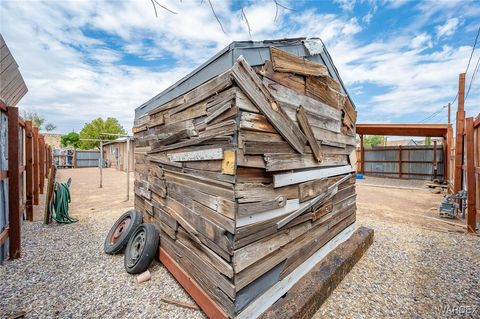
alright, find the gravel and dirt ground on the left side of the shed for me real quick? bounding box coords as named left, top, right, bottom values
left=0, top=168, right=205, bottom=318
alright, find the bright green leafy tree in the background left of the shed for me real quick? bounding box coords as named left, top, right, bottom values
left=79, top=117, right=127, bottom=150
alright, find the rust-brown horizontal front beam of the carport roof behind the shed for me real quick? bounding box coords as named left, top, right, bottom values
left=356, top=124, right=449, bottom=138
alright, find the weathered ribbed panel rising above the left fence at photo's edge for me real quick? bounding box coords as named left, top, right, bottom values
left=0, top=34, right=28, bottom=106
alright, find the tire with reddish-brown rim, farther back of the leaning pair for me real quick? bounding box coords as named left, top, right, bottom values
left=103, top=209, right=143, bottom=255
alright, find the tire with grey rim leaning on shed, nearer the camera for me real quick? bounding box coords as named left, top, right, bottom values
left=125, top=224, right=160, bottom=274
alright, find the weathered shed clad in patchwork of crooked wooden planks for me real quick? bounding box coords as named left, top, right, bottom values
left=134, top=38, right=356, bottom=318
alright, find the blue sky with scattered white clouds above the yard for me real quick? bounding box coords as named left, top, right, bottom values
left=0, top=0, right=480, bottom=133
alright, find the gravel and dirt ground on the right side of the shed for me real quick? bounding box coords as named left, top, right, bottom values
left=314, top=186, right=480, bottom=319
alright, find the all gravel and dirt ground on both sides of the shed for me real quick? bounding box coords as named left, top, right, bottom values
left=0, top=169, right=480, bottom=318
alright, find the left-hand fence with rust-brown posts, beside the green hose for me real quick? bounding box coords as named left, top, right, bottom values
left=0, top=101, right=52, bottom=262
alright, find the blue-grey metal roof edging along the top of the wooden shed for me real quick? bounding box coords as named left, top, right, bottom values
left=135, top=38, right=355, bottom=119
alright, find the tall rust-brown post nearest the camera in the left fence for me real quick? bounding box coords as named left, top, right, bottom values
left=7, top=106, right=21, bottom=259
